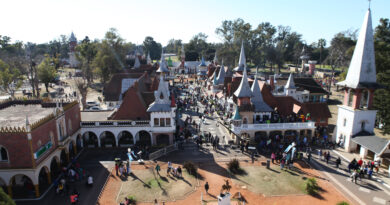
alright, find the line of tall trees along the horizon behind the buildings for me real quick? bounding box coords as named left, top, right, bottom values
left=0, top=19, right=390, bottom=133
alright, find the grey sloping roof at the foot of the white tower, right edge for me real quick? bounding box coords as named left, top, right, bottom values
left=351, top=131, right=390, bottom=156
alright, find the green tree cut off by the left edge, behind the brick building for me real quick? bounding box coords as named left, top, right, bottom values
left=0, top=59, right=23, bottom=98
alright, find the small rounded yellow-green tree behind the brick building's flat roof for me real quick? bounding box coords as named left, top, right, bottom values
left=38, top=55, right=58, bottom=92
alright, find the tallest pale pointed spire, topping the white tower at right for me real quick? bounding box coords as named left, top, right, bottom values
left=337, top=9, right=377, bottom=88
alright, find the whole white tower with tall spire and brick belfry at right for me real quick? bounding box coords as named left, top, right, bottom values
left=336, top=9, right=379, bottom=152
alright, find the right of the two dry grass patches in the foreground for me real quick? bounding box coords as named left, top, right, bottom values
left=232, top=166, right=306, bottom=196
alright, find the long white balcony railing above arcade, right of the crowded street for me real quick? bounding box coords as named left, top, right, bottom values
left=233, top=122, right=316, bottom=131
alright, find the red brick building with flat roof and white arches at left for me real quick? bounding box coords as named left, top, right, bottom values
left=0, top=100, right=82, bottom=199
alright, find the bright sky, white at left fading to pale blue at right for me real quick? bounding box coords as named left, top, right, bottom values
left=0, top=0, right=390, bottom=46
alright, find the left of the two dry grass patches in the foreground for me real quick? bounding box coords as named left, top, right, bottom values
left=117, top=169, right=197, bottom=203
